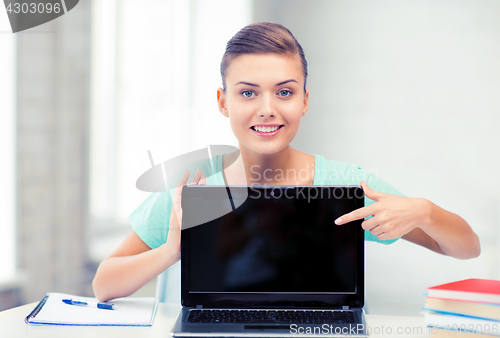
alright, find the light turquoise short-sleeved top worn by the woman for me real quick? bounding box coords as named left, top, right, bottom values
left=129, top=155, right=403, bottom=249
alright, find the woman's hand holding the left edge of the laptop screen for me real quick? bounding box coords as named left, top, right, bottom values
left=162, top=169, right=206, bottom=262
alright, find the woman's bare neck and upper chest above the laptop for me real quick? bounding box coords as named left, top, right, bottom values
left=224, top=145, right=314, bottom=185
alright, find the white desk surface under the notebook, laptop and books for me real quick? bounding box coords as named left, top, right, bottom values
left=0, top=303, right=429, bottom=338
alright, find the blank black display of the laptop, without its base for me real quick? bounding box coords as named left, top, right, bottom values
left=182, top=185, right=360, bottom=294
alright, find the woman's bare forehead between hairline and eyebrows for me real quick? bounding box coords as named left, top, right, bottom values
left=226, top=53, right=305, bottom=83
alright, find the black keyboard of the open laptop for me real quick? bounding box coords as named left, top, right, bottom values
left=187, top=309, right=354, bottom=324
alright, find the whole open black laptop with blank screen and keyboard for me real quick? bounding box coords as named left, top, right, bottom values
left=172, top=185, right=367, bottom=337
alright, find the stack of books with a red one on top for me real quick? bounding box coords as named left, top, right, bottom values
left=423, top=279, right=500, bottom=338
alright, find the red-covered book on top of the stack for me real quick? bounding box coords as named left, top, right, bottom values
left=427, top=279, right=500, bottom=304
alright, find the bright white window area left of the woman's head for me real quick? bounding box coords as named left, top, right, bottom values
left=90, top=0, right=251, bottom=234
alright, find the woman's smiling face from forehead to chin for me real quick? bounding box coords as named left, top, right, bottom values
left=218, top=54, right=308, bottom=154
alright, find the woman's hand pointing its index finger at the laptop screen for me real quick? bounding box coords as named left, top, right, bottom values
left=335, top=180, right=431, bottom=240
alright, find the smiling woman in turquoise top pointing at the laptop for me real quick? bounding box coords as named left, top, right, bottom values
left=93, top=23, right=480, bottom=300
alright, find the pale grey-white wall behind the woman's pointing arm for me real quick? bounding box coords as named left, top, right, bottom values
left=254, top=0, right=500, bottom=315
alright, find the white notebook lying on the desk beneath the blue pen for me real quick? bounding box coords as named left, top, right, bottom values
left=25, top=292, right=158, bottom=326
